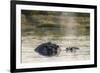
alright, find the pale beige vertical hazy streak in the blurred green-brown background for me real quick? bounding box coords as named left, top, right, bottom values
left=61, top=13, right=79, bottom=36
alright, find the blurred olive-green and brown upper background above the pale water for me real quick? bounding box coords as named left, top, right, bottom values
left=21, top=10, right=90, bottom=36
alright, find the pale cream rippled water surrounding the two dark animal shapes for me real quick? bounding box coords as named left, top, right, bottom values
left=22, top=36, right=90, bottom=63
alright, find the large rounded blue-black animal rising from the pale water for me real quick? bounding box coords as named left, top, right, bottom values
left=35, top=42, right=59, bottom=57
